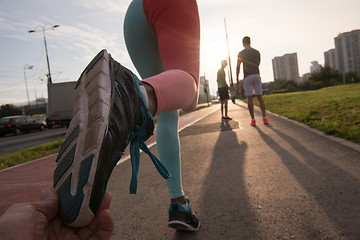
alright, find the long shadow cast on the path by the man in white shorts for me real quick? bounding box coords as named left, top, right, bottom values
left=256, top=125, right=360, bottom=239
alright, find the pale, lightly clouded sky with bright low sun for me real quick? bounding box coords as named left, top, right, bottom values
left=0, top=0, right=360, bottom=105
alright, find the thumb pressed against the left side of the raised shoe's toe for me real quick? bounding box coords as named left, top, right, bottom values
left=32, top=188, right=59, bottom=220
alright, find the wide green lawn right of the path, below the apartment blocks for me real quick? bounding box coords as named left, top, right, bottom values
left=254, top=83, right=360, bottom=144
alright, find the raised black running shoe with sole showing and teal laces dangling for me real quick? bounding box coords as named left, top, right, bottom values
left=54, top=50, right=169, bottom=227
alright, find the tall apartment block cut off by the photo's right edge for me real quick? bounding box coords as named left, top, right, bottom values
left=335, top=29, right=360, bottom=75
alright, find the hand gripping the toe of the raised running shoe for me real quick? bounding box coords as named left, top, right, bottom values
left=0, top=188, right=114, bottom=240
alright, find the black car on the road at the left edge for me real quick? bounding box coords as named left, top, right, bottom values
left=0, top=116, right=45, bottom=136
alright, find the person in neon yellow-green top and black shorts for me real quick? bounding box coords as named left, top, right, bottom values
left=217, top=60, right=231, bottom=120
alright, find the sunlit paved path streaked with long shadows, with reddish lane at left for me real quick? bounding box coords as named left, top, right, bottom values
left=0, top=103, right=360, bottom=240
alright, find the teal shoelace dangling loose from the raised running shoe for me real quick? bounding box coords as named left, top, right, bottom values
left=130, top=111, right=170, bottom=194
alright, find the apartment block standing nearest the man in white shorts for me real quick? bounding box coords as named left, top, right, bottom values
left=272, top=53, right=300, bottom=83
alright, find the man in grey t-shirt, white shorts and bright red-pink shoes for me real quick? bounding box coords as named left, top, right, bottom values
left=236, top=37, right=269, bottom=126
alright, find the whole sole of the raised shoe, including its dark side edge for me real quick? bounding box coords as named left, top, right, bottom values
left=54, top=50, right=136, bottom=227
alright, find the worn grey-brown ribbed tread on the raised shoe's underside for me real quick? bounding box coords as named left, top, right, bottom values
left=54, top=51, right=111, bottom=226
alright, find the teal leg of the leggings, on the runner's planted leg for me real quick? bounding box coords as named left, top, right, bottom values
left=124, top=0, right=184, bottom=199
